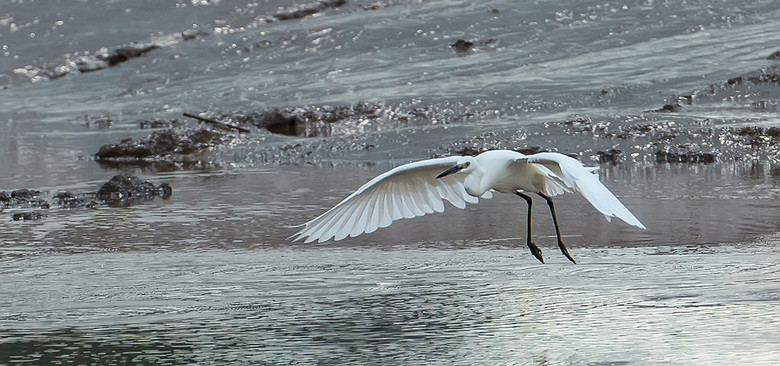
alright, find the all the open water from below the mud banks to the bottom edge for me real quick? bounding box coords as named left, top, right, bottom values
left=0, top=165, right=780, bottom=365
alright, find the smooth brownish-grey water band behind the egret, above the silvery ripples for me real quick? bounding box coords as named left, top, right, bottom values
left=0, top=163, right=780, bottom=260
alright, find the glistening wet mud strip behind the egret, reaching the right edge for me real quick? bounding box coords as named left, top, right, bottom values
left=442, top=116, right=780, bottom=164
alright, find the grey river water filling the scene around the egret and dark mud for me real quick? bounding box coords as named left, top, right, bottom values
left=0, top=0, right=780, bottom=365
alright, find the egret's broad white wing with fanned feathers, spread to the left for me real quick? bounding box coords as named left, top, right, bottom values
left=290, top=156, right=489, bottom=243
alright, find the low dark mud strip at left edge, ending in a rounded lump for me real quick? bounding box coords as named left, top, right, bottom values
left=0, top=174, right=173, bottom=221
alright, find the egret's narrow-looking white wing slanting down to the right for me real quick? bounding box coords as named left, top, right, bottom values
left=517, top=152, right=645, bottom=229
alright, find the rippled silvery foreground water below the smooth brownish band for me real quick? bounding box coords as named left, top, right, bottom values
left=0, top=242, right=780, bottom=365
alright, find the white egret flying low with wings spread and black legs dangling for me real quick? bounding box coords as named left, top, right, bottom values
left=290, top=150, right=645, bottom=263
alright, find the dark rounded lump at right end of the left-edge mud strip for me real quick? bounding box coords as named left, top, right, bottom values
left=97, top=174, right=173, bottom=205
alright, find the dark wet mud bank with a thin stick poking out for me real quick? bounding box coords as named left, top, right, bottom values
left=94, top=102, right=501, bottom=167
